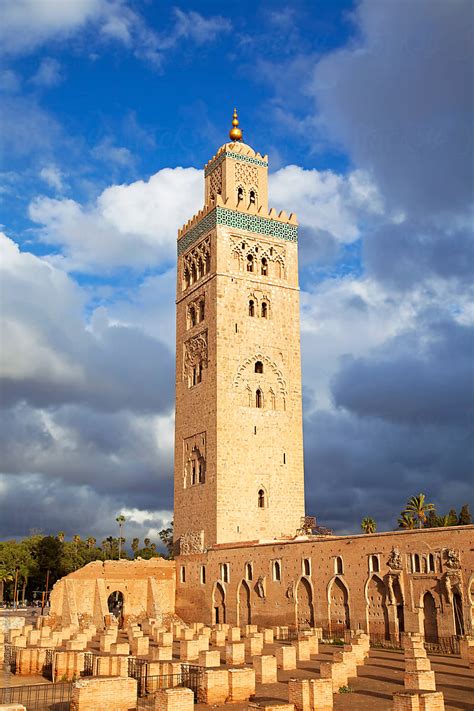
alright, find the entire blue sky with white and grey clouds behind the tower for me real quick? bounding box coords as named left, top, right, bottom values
left=0, top=0, right=473, bottom=538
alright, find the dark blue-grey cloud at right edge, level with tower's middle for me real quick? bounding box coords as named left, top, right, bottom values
left=332, top=319, right=474, bottom=428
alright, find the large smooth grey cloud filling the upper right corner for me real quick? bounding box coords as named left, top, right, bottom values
left=312, top=0, right=474, bottom=217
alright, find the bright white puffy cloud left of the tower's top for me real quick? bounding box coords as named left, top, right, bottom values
left=29, top=168, right=203, bottom=271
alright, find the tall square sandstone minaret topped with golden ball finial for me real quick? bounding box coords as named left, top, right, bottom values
left=174, top=110, right=304, bottom=555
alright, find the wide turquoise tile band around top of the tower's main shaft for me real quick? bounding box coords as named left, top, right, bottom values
left=178, top=207, right=298, bottom=255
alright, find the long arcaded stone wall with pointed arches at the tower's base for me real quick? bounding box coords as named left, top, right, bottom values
left=176, top=526, right=474, bottom=637
